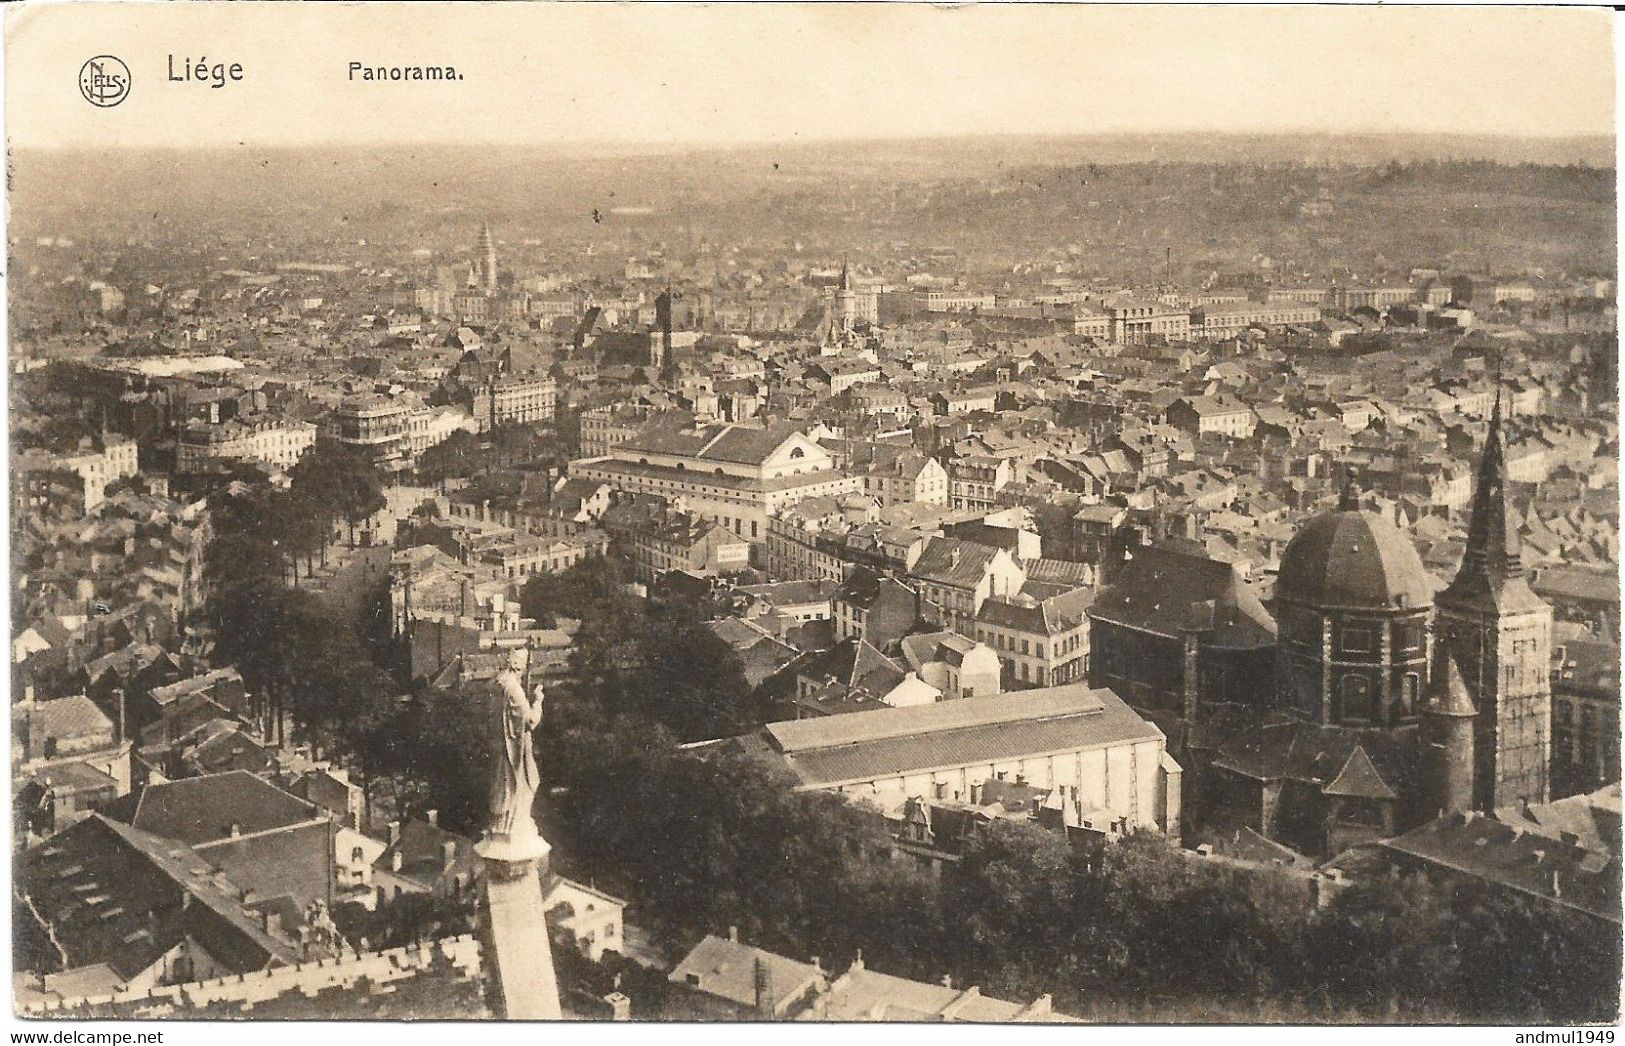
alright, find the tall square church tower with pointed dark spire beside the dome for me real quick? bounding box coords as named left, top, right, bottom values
left=1433, top=395, right=1552, bottom=810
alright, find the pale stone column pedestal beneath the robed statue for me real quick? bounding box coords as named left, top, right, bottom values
left=475, top=835, right=564, bottom=1020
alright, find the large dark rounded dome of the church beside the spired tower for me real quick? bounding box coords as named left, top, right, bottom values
left=1276, top=495, right=1433, bottom=611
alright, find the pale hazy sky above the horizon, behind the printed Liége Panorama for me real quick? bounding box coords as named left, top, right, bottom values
left=7, top=3, right=1614, bottom=148
